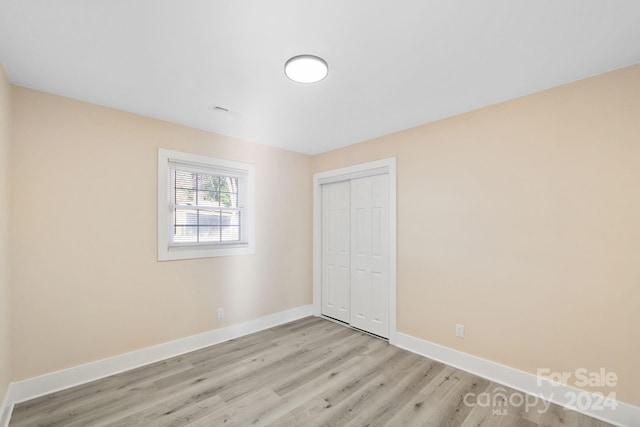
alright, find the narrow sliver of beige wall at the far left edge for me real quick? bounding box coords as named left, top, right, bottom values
left=0, top=63, right=12, bottom=404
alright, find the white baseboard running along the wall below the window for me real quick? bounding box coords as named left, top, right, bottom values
left=0, top=305, right=313, bottom=427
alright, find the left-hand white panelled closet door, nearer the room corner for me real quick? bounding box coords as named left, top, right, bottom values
left=322, top=181, right=351, bottom=323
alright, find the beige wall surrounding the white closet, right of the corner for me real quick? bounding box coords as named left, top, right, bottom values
left=313, top=66, right=640, bottom=405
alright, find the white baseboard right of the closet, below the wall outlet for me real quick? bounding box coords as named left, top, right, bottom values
left=396, top=333, right=640, bottom=427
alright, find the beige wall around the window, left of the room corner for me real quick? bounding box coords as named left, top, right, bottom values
left=12, top=87, right=312, bottom=381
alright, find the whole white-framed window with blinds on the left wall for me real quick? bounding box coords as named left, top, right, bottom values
left=158, top=149, right=254, bottom=261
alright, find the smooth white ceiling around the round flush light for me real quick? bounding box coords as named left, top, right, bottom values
left=0, top=0, right=640, bottom=154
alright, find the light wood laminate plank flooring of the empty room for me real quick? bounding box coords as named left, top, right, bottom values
left=10, top=317, right=608, bottom=427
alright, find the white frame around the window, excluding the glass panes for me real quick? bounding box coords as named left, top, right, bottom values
left=158, top=148, right=255, bottom=261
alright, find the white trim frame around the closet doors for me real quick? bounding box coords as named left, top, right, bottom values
left=313, top=157, right=397, bottom=344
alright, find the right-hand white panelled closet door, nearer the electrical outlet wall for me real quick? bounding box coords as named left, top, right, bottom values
left=350, top=175, right=389, bottom=338
